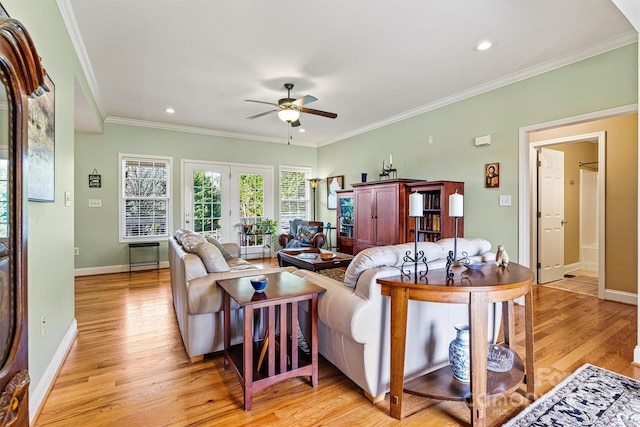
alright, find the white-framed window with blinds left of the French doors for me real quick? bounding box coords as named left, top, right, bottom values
left=119, top=154, right=171, bottom=242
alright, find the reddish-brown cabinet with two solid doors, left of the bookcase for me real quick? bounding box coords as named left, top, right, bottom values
left=353, top=179, right=424, bottom=253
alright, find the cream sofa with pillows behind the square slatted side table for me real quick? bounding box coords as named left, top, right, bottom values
left=169, top=230, right=296, bottom=362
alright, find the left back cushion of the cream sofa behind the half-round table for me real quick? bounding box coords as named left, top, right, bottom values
left=344, top=242, right=446, bottom=288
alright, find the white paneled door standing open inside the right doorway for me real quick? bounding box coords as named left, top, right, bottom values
left=538, top=148, right=565, bottom=283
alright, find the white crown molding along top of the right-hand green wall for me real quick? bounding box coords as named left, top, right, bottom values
left=318, top=31, right=638, bottom=147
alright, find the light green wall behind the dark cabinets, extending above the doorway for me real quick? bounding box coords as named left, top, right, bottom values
left=318, top=44, right=638, bottom=261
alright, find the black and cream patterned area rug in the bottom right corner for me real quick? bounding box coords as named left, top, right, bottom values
left=504, top=364, right=640, bottom=427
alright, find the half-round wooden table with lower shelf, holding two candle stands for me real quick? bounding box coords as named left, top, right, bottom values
left=378, top=263, right=535, bottom=426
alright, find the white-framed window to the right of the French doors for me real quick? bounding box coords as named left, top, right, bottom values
left=279, top=166, right=311, bottom=232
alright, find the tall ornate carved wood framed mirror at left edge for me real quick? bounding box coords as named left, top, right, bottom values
left=0, top=18, right=47, bottom=427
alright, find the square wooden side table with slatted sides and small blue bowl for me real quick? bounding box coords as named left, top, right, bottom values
left=218, top=272, right=326, bottom=411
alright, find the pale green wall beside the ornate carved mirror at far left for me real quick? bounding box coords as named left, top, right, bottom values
left=2, top=0, right=100, bottom=415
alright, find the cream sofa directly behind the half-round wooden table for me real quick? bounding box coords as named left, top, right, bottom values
left=294, top=238, right=501, bottom=402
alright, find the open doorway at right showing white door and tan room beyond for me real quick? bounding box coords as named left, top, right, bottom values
left=534, top=139, right=606, bottom=295
